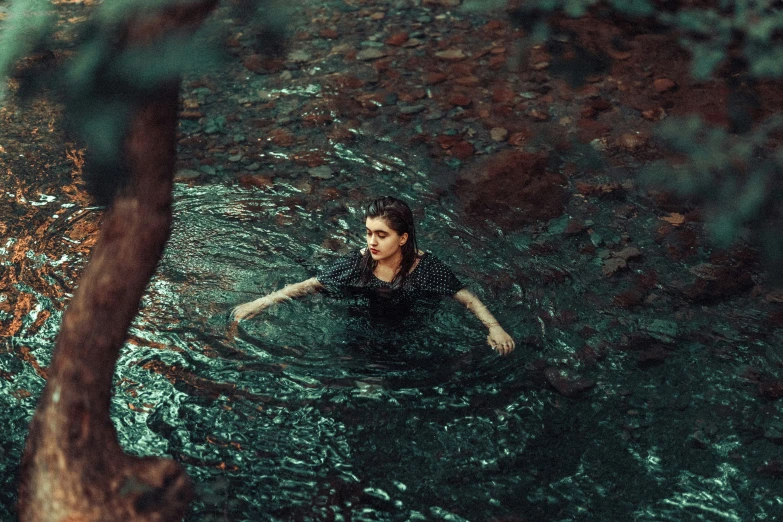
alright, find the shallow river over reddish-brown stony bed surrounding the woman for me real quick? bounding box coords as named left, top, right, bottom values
left=0, top=0, right=783, bottom=521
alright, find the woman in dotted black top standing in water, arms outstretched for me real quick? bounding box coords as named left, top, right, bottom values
left=232, top=197, right=515, bottom=355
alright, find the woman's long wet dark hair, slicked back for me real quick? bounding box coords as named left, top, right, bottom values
left=360, top=196, right=419, bottom=288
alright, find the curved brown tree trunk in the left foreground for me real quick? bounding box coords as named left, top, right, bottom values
left=19, top=0, right=217, bottom=522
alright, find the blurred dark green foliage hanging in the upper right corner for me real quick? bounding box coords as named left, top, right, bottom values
left=466, top=0, right=783, bottom=276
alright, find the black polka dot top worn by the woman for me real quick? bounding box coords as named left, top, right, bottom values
left=316, top=250, right=465, bottom=302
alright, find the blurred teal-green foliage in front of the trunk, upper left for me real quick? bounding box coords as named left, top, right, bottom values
left=0, top=0, right=286, bottom=204
